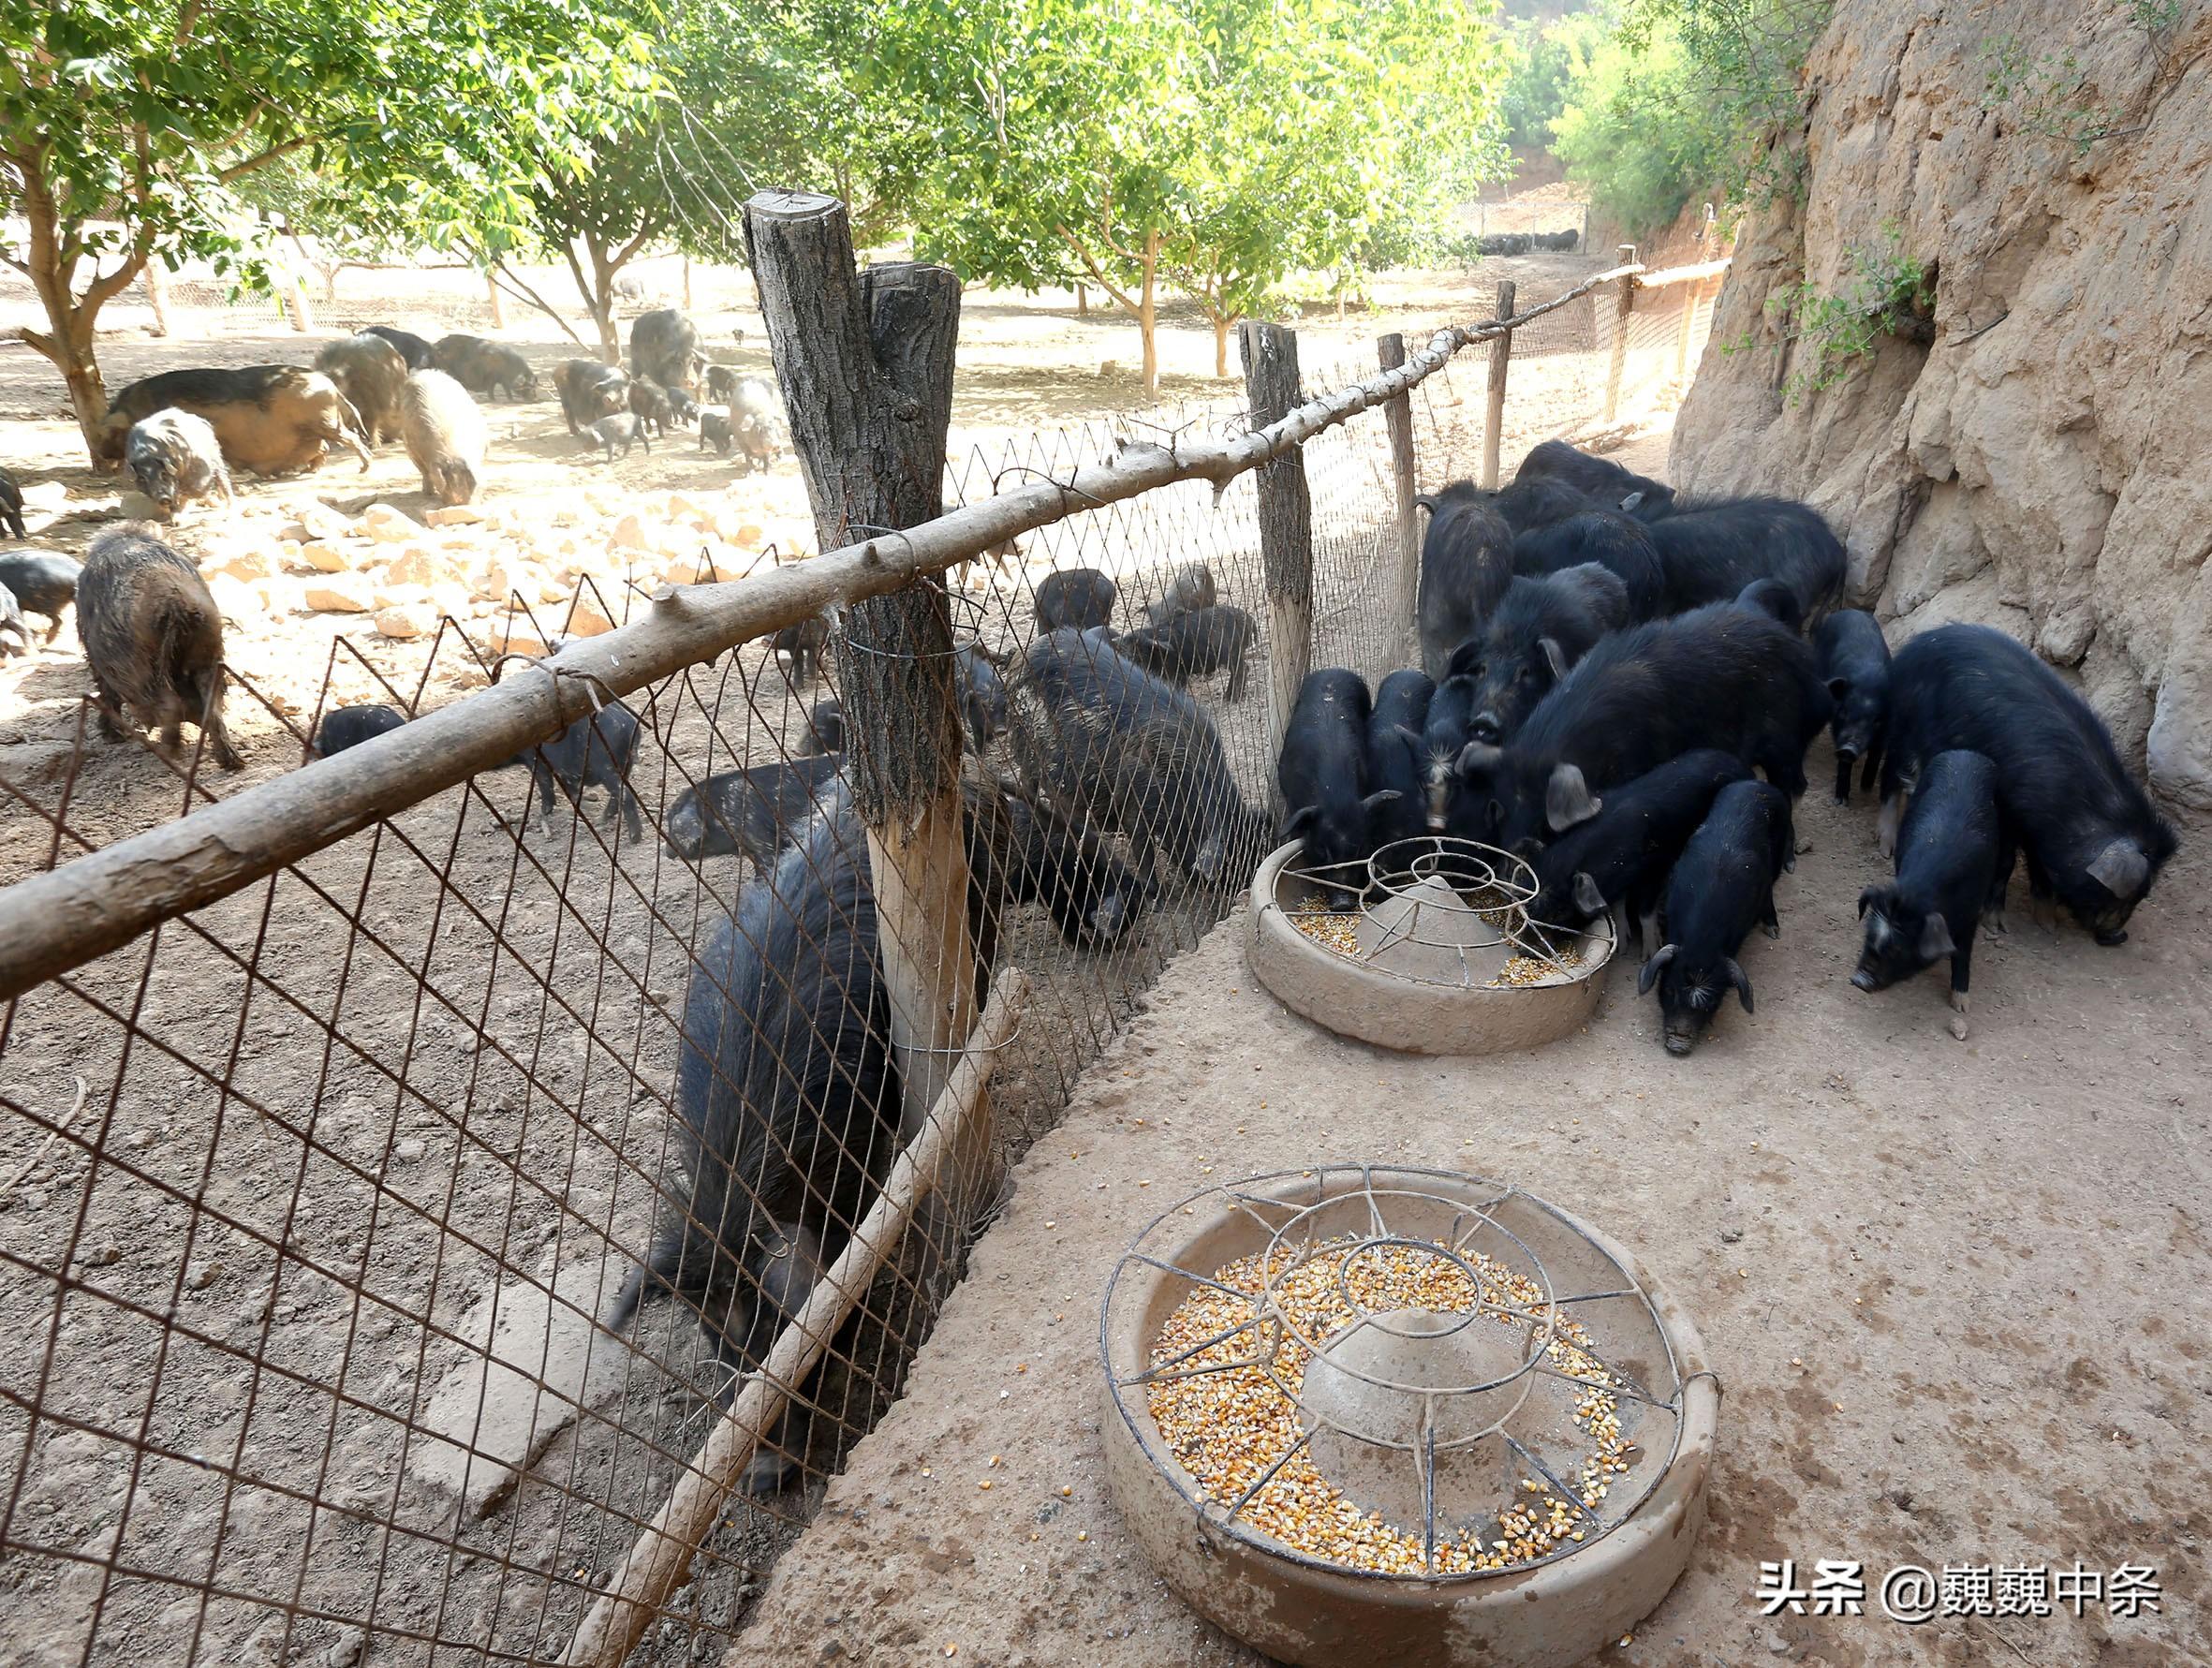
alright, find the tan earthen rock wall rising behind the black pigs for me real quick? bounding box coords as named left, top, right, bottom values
left=1673, top=0, right=2212, bottom=807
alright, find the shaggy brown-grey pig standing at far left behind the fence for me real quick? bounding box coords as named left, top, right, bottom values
left=78, top=526, right=245, bottom=770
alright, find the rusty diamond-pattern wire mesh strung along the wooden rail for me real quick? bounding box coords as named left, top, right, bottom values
left=0, top=270, right=1701, bottom=1666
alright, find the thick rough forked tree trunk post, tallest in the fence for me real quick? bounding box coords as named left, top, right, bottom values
left=745, top=190, right=989, bottom=1168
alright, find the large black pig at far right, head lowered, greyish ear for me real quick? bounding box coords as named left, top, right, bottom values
left=1882, top=626, right=2179, bottom=945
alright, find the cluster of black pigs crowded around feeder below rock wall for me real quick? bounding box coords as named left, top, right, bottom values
left=1278, top=440, right=2175, bottom=1053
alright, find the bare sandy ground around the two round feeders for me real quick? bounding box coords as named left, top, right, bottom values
left=730, top=744, right=2212, bottom=1668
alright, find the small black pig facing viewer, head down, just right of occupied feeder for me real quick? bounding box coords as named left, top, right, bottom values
left=1637, top=781, right=1796, bottom=1055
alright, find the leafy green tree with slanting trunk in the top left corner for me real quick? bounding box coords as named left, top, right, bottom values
left=0, top=0, right=650, bottom=462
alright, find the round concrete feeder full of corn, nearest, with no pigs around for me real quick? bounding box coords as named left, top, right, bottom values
left=1101, top=1163, right=1718, bottom=1668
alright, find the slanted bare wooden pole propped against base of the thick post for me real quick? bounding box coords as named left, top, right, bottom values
left=562, top=969, right=1028, bottom=1668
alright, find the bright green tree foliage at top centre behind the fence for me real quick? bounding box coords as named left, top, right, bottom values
left=858, top=0, right=1502, bottom=393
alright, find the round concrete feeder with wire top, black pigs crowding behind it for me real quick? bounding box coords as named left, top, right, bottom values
left=1246, top=834, right=1615, bottom=1053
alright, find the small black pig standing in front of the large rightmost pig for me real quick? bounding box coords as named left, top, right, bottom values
left=1851, top=747, right=2013, bottom=1042
